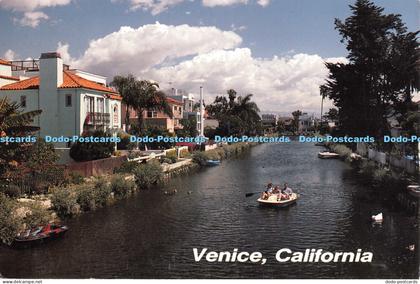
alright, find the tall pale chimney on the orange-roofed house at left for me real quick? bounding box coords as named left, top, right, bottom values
left=39, top=52, right=63, bottom=136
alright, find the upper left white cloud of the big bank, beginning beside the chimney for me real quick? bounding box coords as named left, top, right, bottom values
left=59, top=23, right=242, bottom=74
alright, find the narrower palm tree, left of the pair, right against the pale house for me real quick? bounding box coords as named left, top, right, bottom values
left=111, top=74, right=137, bottom=131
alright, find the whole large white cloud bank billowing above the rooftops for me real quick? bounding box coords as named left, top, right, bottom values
left=58, top=23, right=345, bottom=112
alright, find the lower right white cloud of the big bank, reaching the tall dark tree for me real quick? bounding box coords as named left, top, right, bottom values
left=146, top=48, right=344, bottom=112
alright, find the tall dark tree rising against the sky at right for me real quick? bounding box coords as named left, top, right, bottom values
left=322, top=0, right=419, bottom=137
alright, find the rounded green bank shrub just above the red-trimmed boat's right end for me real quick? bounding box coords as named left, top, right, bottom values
left=51, top=188, right=79, bottom=217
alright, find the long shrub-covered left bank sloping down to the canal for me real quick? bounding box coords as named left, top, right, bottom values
left=0, top=143, right=256, bottom=244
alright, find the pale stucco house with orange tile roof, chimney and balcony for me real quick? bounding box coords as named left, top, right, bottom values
left=0, top=52, right=122, bottom=147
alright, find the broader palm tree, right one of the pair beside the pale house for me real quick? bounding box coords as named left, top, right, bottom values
left=134, top=80, right=173, bottom=131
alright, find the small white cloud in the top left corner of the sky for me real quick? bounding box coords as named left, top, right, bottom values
left=0, top=0, right=71, bottom=28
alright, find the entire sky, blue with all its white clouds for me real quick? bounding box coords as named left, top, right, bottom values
left=0, top=0, right=420, bottom=113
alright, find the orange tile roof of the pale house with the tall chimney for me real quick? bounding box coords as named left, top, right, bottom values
left=0, top=71, right=122, bottom=100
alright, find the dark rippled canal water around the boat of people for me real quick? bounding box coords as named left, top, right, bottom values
left=0, top=142, right=419, bottom=278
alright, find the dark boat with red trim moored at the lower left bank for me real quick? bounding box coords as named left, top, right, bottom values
left=12, top=224, right=69, bottom=248
